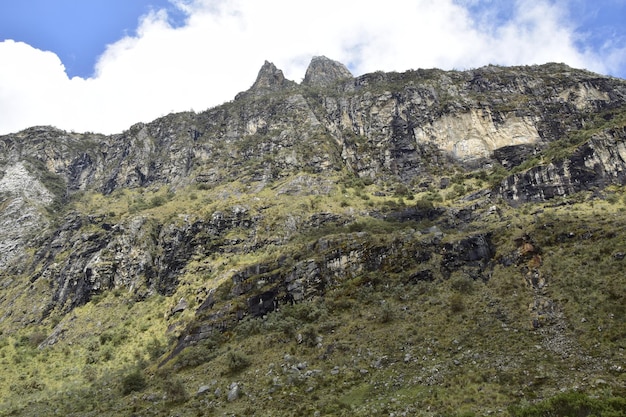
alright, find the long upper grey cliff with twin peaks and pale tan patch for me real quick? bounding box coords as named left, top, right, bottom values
left=2, top=57, right=626, bottom=194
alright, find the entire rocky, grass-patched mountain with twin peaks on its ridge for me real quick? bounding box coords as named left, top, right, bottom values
left=0, top=57, right=626, bottom=416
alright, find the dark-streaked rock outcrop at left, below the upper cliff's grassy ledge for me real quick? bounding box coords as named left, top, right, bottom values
left=25, top=203, right=253, bottom=315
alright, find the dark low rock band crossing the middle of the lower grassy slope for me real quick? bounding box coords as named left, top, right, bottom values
left=170, top=229, right=495, bottom=358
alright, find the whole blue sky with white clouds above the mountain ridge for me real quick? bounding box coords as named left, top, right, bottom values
left=0, top=0, right=626, bottom=134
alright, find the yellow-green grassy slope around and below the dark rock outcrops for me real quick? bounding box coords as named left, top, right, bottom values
left=0, top=170, right=626, bottom=416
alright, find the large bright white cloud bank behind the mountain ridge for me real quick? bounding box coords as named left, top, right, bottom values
left=0, top=0, right=623, bottom=133
